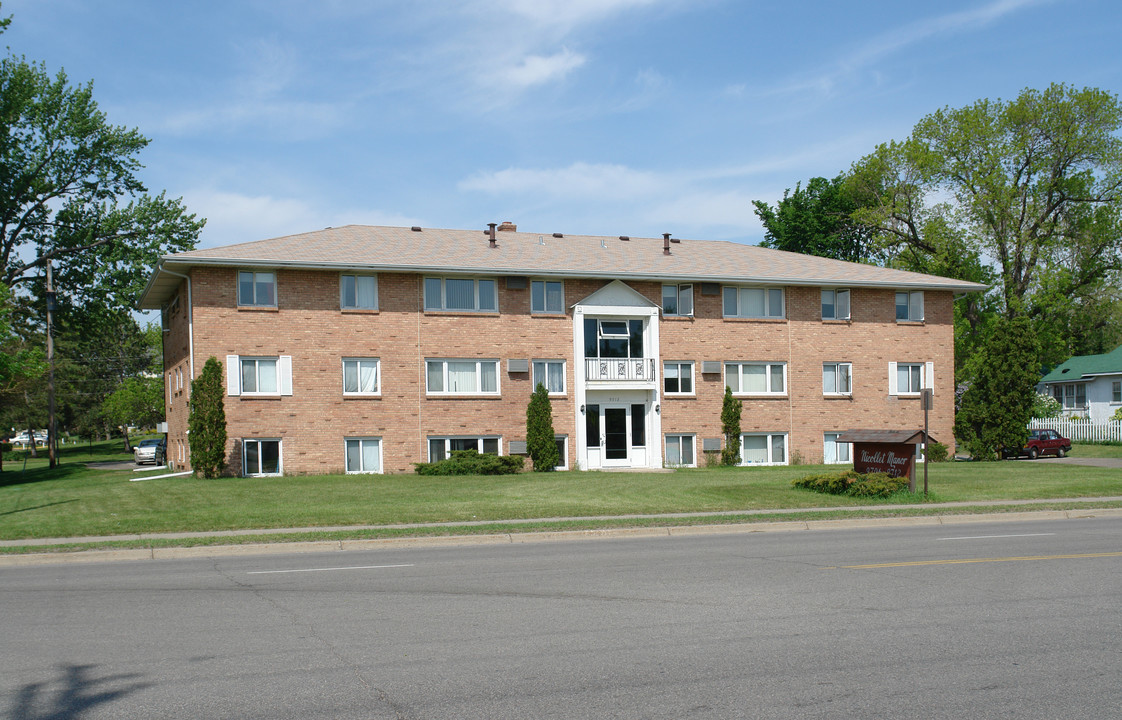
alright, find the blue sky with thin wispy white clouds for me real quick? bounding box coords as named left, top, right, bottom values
left=0, top=0, right=1122, bottom=248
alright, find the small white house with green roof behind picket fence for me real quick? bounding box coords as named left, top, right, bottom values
left=1038, top=345, right=1122, bottom=423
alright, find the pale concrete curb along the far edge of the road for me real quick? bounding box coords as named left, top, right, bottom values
left=0, top=508, right=1122, bottom=567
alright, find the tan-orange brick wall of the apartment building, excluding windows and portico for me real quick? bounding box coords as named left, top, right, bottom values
left=172, top=268, right=954, bottom=473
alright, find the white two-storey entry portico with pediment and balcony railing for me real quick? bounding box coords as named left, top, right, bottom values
left=573, top=280, right=662, bottom=470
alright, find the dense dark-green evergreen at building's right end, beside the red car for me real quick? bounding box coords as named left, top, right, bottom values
left=955, top=315, right=1040, bottom=460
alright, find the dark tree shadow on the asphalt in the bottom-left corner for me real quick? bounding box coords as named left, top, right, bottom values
left=8, top=665, right=155, bottom=720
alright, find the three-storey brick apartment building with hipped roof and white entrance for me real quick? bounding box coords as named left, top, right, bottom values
left=139, top=223, right=983, bottom=474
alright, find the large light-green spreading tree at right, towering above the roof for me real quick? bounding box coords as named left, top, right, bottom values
left=849, top=84, right=1122, bottom=327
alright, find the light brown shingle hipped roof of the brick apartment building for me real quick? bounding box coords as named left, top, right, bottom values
left=139, top=225, right=985, bottom=308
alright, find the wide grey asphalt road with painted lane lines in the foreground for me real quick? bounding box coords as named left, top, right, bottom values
left=0, top=518, right=1122, bottom=720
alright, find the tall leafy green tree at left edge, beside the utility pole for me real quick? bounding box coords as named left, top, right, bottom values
left=0, top=56, right=204, bottom=308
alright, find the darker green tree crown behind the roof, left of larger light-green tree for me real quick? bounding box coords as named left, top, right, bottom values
left=753, top=174, right=881, bottom=262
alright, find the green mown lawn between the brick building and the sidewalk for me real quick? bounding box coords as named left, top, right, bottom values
left=0, top=442, right=1122, bottom=539
